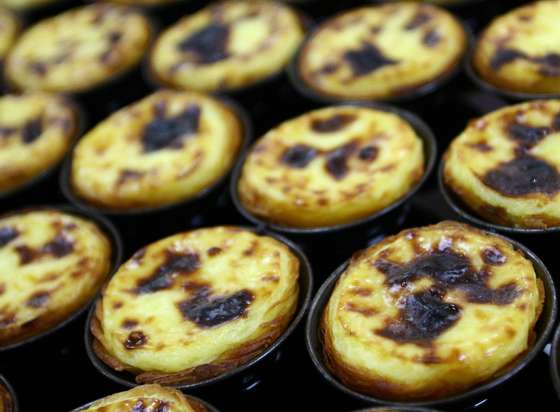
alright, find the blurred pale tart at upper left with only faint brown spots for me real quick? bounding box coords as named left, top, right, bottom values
left=6, top=4, right=151, bottom=93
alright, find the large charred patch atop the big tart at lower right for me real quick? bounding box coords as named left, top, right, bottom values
left=374, top=248, right=521, bottom=345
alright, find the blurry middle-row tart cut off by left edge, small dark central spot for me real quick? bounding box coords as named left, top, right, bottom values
left=0, top=93, right=78, bottom=193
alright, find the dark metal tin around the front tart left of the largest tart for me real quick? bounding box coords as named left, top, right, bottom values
left=84, top=226, right=313, bottom=391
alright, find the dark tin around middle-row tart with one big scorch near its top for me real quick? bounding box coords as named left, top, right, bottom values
left=59, top=96, right=253, bottom=218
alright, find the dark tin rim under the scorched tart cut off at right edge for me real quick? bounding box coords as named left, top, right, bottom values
left=438, top=159, right=560, bottom=236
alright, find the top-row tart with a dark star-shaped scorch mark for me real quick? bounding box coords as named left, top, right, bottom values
left=298, top=3, right=466, bottom=99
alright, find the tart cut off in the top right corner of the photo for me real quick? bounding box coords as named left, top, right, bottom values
left=473, top=0, right=560, bottom=93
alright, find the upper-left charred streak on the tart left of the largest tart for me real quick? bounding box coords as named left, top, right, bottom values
left=134, top=251, right=200, bottom=295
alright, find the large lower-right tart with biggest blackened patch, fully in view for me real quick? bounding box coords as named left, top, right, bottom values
left=322, top=222, right=544, bottom=401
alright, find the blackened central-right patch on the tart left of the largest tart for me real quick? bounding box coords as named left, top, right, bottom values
left=178, top=288, right=255, bottom=328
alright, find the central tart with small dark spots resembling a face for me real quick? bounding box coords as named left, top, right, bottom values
left=237, top=106, right=425, bottom=227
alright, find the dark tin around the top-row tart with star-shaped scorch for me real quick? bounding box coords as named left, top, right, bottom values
left=287, top=14, right=472, bottom=105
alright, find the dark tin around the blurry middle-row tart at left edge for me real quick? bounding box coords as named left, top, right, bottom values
left=0, top=96, right=87, bottom=212
